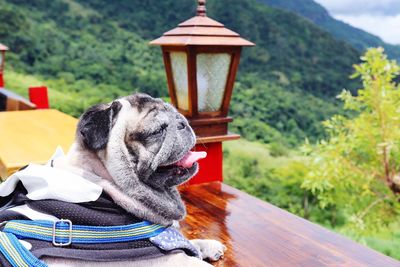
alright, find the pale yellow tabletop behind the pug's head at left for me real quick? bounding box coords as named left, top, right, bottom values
left=0, top=109, right=78, bottom=179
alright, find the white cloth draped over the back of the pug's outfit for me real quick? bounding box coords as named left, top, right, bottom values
left=0, top=148, right=103, bottom=203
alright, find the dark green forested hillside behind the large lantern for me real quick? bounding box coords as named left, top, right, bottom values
left=0, top=0, right=359, bottom=145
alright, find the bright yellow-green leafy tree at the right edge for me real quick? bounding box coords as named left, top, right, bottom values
left=302, top=48, right=400, bottom=237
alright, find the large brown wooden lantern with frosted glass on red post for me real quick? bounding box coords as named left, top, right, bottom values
left=150, top=0, right=254, bottom=183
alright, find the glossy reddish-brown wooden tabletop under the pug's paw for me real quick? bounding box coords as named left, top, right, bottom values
left=181, top=183, right=400, bottom=267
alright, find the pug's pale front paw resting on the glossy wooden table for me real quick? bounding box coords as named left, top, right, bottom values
left=190, top=239, right=226, bottom=261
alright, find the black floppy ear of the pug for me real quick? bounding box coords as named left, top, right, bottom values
left=77, top=101, right=122, bottom=151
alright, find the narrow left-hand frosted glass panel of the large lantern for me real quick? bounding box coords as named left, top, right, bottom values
left=170, top=52, right=189, bottom=111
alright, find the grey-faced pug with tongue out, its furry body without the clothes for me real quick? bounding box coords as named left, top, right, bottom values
left=39, top=94, right=226, bottom=267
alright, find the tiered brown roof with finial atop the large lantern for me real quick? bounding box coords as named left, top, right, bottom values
left=150, top=0, right=254, bottom=46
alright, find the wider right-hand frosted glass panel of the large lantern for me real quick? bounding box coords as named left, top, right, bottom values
left=197, top=53, right=232, bottom=112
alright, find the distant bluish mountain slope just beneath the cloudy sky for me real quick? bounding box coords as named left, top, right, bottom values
left=258, top=0, right=400, bottom=60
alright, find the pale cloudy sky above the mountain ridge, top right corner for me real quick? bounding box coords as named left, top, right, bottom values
left=314, top=0, right=400, bottom=44
